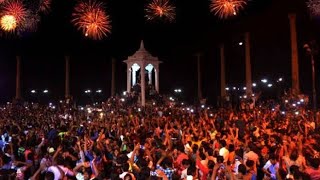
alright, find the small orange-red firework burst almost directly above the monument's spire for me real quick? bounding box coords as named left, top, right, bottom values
left=145, top=0, right=176, bottom=21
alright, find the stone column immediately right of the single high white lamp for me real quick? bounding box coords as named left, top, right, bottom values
left=245, top=32, right=252, bottom=94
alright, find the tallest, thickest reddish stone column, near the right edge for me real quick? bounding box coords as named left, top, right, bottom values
left=288, top=13, right=300, bottom=93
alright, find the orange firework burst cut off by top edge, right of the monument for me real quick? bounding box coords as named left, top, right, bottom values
left=210, top=0, right=247, bottom=19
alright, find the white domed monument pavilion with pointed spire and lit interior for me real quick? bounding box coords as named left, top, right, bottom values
left=124, top=41, right=162, bottom=106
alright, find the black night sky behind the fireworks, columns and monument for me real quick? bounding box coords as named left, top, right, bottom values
left=0, top=0, right=320, bottom=104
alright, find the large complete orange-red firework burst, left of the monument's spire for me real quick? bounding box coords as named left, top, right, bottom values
left=71, top=0, right=111, bottom=40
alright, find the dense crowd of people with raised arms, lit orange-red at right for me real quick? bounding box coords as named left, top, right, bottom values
left=0, top=90, right=320, bottom=180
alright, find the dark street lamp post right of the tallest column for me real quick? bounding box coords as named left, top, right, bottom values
left=303, top=41, right=318, bottom=126
